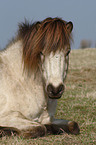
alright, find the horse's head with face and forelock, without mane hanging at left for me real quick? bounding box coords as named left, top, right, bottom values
left=38, top=19, right=73, bottom=99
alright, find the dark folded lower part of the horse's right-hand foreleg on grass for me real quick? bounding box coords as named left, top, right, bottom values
left=45, top=119, right=80, bottom=135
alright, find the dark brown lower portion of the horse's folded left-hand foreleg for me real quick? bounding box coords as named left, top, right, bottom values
left=0, top=125, right=46, bottom=138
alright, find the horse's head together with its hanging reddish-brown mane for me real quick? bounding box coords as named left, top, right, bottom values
left=19, top=18, right=73, bottom=99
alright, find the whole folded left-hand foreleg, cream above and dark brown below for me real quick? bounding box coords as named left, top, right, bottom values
left=0, top=112, right=47, bottom=138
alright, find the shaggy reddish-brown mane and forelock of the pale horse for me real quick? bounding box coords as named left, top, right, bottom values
left=18, top=18, right=71, bottom=70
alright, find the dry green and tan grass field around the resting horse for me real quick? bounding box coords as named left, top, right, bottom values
left=0, top=48, right=96, bottom=145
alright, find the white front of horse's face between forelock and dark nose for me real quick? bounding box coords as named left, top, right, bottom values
left=42, top=52, right=66, bottom=87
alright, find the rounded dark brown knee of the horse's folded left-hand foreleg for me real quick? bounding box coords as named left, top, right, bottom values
left=20, top=125, right=47, bottom=138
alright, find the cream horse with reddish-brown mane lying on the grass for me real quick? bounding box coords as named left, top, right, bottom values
left=0, top=17, right=80, bottom=138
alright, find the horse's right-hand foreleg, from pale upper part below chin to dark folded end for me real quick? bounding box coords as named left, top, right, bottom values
left=45, top=99, right=80, bottom=134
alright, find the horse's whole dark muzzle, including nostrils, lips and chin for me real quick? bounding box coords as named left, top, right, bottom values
left=47, top=84, right=65, bottom=99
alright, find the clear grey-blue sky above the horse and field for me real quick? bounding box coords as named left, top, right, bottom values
left=0, top=0, right=96, bottom=49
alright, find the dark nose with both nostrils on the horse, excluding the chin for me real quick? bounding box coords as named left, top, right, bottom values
left=47, top=84, right=64, bottom=96
